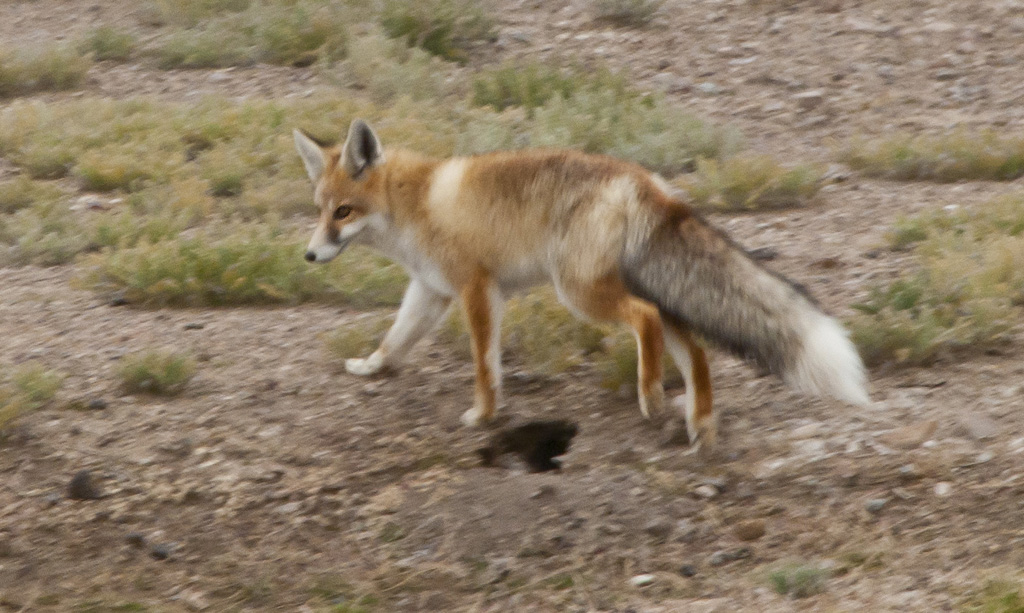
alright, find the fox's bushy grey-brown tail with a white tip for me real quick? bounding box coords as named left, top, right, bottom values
left=622, top=210, right=869, bottom=405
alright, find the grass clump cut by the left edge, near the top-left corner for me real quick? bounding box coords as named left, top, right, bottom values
left=0, top=45, right=92, bottom=98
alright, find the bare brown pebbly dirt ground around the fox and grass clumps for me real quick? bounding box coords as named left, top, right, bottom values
left=0, top=0, right=1024, bottom=613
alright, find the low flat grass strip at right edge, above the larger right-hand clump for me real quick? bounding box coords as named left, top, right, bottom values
left=839, top=130, right=1024, bottom=182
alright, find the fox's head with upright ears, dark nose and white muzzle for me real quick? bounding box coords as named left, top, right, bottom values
left=294, top=119, right=383, bottom=263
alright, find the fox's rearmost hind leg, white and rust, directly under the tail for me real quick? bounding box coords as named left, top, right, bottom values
left=663, top=318, right=718, bottom=452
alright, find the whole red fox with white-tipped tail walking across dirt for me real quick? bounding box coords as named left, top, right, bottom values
left=293, top=119, right=869, bottom=451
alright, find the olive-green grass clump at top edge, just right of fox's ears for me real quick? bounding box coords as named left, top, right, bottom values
left=380, top=0, right=495, bottom=61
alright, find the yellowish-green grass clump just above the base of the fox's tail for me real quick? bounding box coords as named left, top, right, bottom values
left=680, top=156, right=822, bottom=211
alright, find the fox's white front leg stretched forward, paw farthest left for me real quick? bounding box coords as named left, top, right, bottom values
left=345, top=278, right=452, bottom=377
